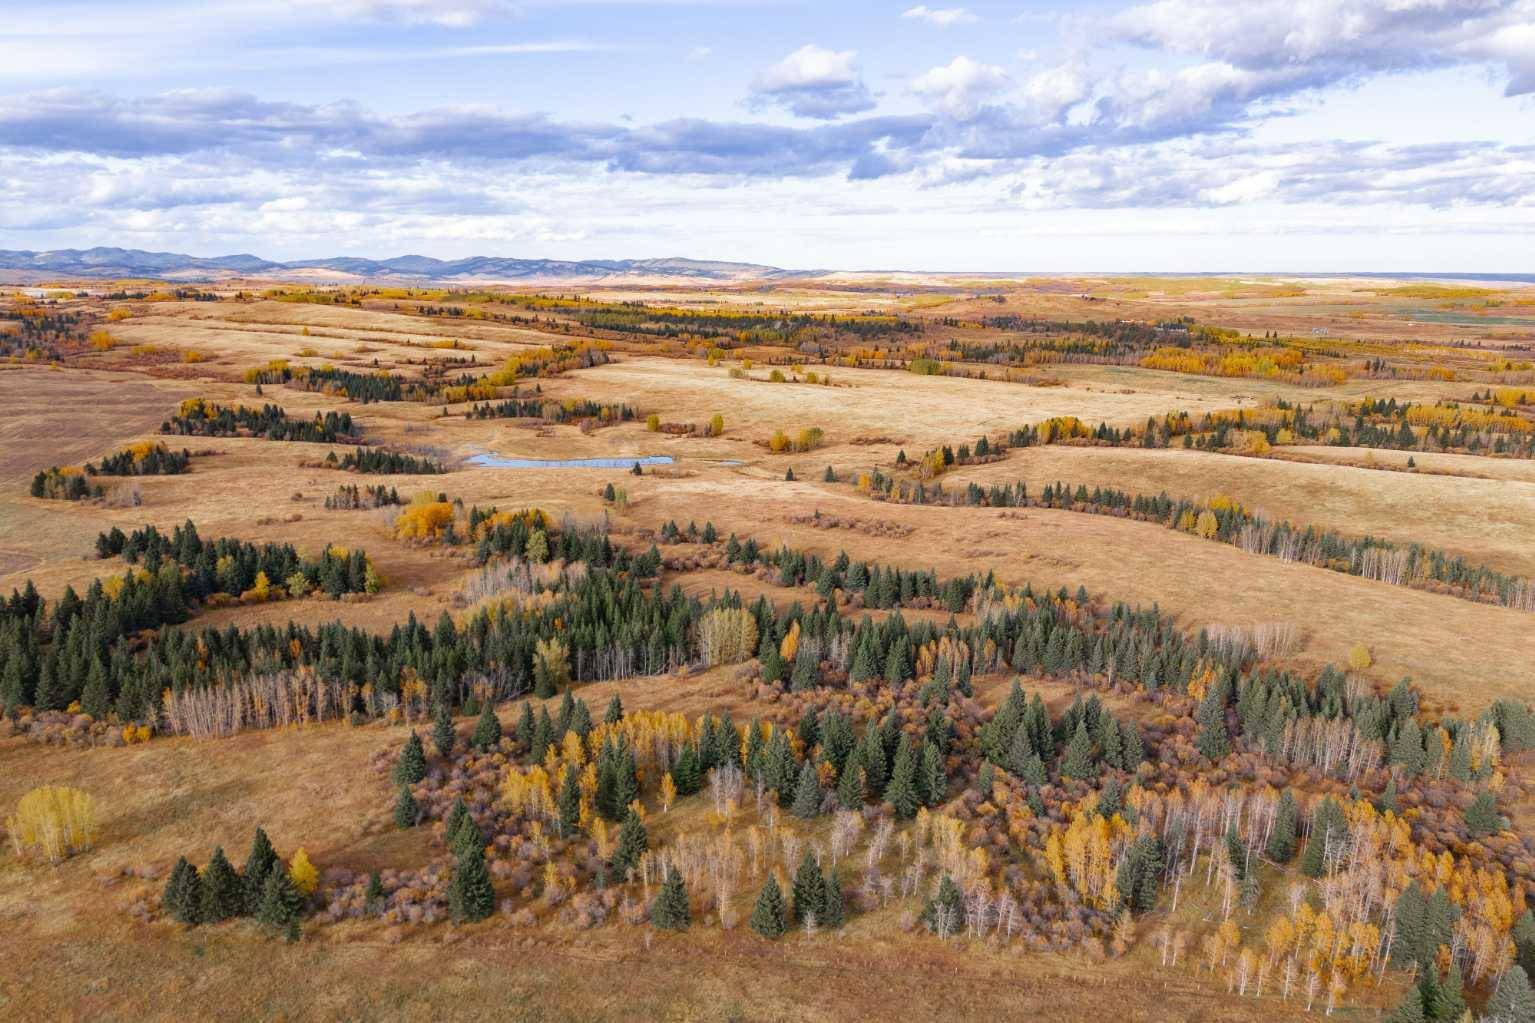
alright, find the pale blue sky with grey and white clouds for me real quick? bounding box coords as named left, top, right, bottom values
left=0, top=0, right=1535, bottom=273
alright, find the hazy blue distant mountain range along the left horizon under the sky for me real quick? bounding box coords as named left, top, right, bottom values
left=0, top=247, right=815, bottom=284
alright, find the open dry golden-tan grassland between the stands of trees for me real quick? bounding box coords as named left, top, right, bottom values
left=0, top=278, right=1535, bottom=1020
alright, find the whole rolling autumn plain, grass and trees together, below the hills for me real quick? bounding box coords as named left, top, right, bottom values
left=0, top=275, right=1535, bottom=1020
